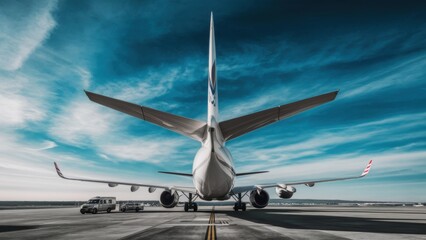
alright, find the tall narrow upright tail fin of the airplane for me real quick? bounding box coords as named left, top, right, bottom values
left=207, top=12, right=218, bottom=125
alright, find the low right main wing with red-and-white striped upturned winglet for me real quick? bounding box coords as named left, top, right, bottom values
left=231, top=160, right=373, bottom=194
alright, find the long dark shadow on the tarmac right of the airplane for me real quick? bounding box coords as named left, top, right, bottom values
left=223, top=209, right=426, bottom=234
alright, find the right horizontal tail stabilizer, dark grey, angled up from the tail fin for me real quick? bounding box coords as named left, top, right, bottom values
left=219, top=91, right=339, bottom=141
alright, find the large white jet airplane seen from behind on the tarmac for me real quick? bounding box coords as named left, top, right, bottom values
left=54, top=13, right=373, bottom=212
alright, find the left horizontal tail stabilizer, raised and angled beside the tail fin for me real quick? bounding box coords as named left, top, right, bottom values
left=85, top=91, right=207, bottom=141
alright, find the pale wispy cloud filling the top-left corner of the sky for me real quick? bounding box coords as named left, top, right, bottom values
left=0, top=0, right=57, bottom=71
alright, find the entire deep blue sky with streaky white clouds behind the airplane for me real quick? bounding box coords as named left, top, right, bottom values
left=0, top=0, right=426, bottom=202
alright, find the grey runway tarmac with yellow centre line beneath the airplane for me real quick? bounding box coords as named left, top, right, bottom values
left=0, top=206, right=426, bottom=240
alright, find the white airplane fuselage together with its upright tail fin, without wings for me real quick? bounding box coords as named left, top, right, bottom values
left=192, top=15, right=235, bottom=200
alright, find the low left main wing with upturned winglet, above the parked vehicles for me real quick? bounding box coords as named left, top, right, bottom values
left=54, top=162, right=196, bottom=194
